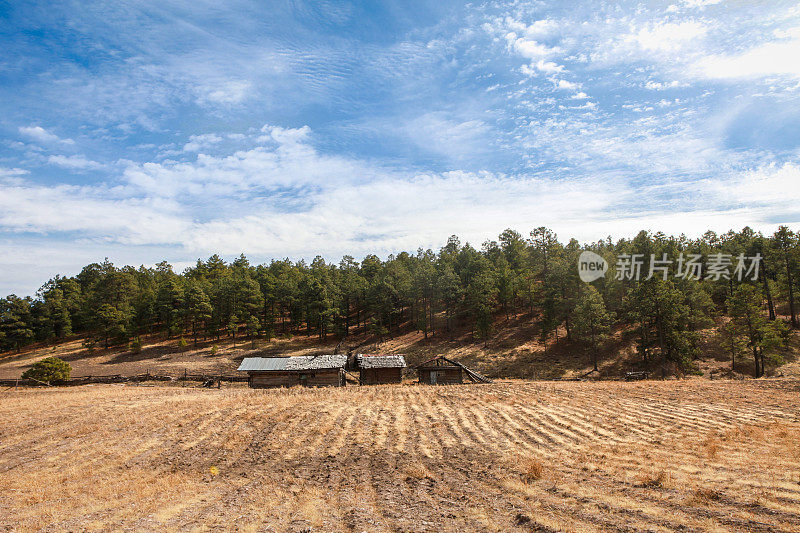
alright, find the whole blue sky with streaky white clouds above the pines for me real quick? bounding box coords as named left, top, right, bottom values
left=0, top=0, right=800, bottom=294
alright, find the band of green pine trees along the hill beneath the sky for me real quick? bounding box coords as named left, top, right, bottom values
left=0, top=226, right=800, bottom=376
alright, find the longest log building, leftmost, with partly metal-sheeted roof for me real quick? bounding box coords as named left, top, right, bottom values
left=239, top=355, right=347, bottom=389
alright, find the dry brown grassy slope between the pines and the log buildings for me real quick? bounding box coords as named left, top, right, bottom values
left=0, top=315, right=800, bottom=379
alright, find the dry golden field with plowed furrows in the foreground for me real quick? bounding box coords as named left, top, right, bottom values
left=0, top=380, right=800, bottom=532
